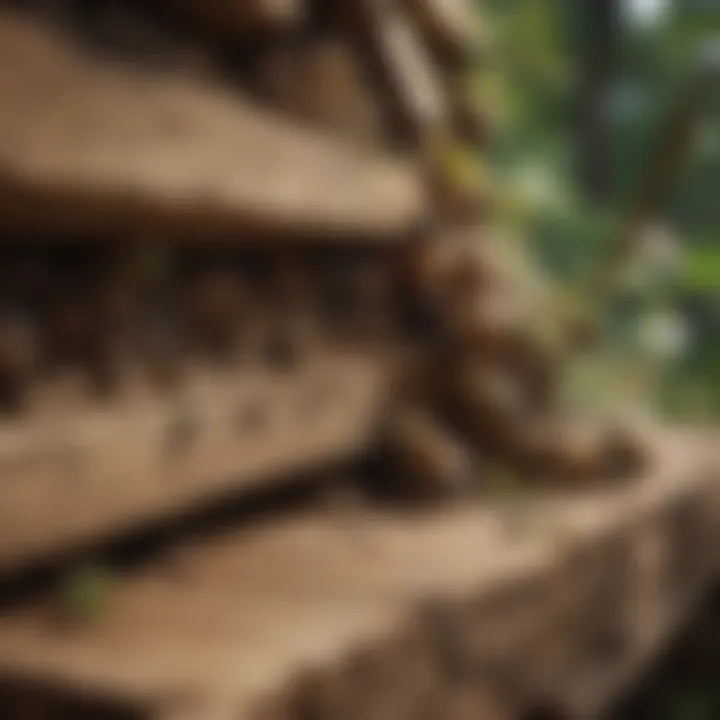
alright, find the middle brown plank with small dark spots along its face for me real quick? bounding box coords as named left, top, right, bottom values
left=0, top=354, right=391, bottom=569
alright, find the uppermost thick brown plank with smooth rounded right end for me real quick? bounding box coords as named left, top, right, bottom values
left=0, top=13, right=424, bottom=236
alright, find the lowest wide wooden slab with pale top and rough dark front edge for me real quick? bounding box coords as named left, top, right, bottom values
left=0, top=433, right=720, bottom=718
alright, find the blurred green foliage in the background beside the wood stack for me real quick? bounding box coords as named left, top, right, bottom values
left=474, top=0, right=720, bottom=417
